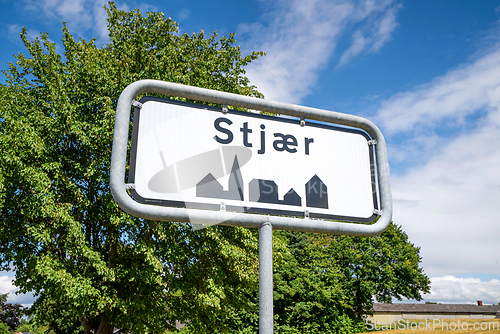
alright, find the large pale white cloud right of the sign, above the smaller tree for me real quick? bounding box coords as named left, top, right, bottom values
left=389, top=118, right=500, bottom=275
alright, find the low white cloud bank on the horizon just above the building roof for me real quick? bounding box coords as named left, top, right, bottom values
left=424, top=276, right=500, bottom=304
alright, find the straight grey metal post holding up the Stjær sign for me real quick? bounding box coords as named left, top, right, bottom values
left=259, top=222, right=273, bottom=334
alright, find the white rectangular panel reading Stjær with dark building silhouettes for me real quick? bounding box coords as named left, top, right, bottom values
left=128, top=97, right=378, bottom=222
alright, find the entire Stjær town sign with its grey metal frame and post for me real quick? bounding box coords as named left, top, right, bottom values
left=110, top=80, right=392, bottom=334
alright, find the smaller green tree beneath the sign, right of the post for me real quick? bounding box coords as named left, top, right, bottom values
left=217, top=224, right=430, bottom=334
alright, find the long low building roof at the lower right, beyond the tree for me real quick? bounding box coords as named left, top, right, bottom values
left=373, top=303, right=500, bottom=314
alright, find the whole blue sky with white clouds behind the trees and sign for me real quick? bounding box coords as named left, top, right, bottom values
left=0, top=0, right=500, bottom=304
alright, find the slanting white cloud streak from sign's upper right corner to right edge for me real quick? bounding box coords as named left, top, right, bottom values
left=376, top=46, right=500, bottom=133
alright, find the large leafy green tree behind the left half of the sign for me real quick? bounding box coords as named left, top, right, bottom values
left=0, top=2, right=262, bottom=334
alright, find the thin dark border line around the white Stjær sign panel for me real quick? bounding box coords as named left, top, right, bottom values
left=128, top=96, right=379, bottom=223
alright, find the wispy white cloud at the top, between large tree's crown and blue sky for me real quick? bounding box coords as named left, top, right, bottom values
left=238, top=0, right=399, bottom=103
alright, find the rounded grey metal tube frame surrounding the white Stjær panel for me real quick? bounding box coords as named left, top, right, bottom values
left=110, top=80, right=392, bottom=236
